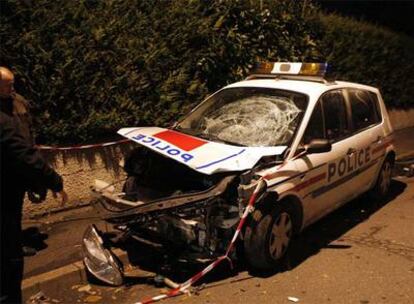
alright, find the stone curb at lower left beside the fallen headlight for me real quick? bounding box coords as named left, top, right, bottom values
left=22, top=249, right=128, bottom=300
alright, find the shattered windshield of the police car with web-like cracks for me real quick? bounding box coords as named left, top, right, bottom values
left=177, top=87, right=307, bottom=147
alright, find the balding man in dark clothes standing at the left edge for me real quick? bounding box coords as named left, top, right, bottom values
left=0, top=67, right=67, bottom=303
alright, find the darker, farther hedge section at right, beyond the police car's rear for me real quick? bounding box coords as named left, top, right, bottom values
left=319, top=15, right=414, bottom=108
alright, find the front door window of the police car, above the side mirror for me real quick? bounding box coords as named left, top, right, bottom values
left=322, top=91, right=349, bottom=141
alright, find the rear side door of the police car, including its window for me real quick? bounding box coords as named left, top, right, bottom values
left=345, top=88, right=384, bottom=196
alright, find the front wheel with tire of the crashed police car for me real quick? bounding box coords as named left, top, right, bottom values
left=244, top=204, right=295, bottom=271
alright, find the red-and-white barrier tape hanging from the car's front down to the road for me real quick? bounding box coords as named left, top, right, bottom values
left=134, top=178, right=266, bottom=304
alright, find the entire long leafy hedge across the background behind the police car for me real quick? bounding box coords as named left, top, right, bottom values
left=0, top=0, right=414, bottom=144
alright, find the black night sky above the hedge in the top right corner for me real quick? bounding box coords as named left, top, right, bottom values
left=317, top=0, right=414, bottom=37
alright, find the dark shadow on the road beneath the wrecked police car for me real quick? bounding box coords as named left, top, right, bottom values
left=98, top=180, right=406, bottom=285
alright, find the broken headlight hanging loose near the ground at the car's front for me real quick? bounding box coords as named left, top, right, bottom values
left=82, top=225, right=123, bottom=286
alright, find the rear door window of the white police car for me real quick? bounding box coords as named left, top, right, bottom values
left=348, top=89, right=380, bottom=130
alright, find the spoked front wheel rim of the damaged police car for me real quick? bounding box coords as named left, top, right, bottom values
left=269, top=212, right=292, bottom=260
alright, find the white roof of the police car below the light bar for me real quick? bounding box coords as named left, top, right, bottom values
left=226, top=79, right=378, bottom=100
